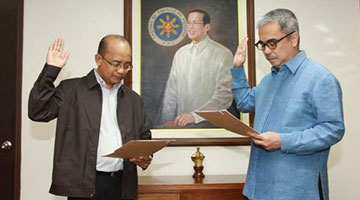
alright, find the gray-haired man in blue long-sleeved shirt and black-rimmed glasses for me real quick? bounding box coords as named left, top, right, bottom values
left=231, top=9, right=345, bottom=200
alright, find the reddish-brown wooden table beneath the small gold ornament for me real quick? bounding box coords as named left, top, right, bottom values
left=138, top=175, right=247, bottom=200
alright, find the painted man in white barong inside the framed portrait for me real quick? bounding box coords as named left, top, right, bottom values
left=161, top=9, right=233, bottom=128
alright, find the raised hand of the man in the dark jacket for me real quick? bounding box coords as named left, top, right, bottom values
left=46, top=38, right=70, bottom=68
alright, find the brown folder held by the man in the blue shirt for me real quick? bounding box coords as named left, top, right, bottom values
left=196, top=110, right=258, bottom=136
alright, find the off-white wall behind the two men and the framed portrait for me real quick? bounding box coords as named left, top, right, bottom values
left=21, top=0, right=360, bottom=200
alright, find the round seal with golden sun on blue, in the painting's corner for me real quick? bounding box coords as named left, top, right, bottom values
left=148, top=7, right=186, bottom=46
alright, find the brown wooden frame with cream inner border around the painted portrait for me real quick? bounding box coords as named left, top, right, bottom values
left=124, top=0, right=256, bottom=146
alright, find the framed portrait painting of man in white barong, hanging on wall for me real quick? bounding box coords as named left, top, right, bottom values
left=125, top=0, right=255, bottom=146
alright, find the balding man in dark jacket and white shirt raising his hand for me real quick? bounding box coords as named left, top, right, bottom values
left=28, top=35, right=152, bottom=200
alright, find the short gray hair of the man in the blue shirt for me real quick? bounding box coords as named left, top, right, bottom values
left=257, top=8, right=299, bottom=34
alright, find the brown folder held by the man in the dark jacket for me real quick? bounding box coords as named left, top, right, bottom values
left=105, top=140, right=171, bottom=159
